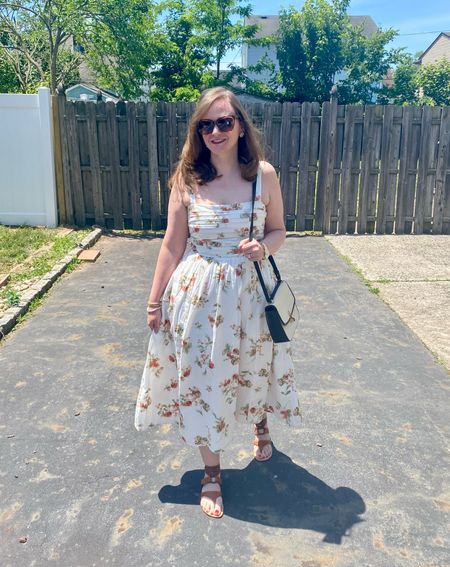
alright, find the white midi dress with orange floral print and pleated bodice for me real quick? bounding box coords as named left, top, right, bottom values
left=135, top=168, right=300, bottom=451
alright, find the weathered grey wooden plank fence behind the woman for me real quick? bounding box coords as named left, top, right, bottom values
left=53, top=96, right=450, bottom=234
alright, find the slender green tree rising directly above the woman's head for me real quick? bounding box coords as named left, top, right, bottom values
left=191, top=0, right=258, bottom=79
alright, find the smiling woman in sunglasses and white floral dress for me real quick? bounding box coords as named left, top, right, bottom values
left=135, top=87, right=300, bottom=518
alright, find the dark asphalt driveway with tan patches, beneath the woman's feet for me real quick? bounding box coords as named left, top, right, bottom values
left=0, top=236, right=450, bottom=567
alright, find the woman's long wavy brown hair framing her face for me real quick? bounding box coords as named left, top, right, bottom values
left=169, top=87, right=263, bottom=191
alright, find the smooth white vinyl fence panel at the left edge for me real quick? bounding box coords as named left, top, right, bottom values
left=0, top=88, right=58, bottom=227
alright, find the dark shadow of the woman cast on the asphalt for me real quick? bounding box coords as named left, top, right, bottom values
left=159, top=449, right=366, bottom=544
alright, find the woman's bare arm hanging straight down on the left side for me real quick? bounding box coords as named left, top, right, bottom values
left=147, top=189, right=189, bottom=331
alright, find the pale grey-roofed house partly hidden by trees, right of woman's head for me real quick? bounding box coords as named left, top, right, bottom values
left=242, top=16, right=378, bottom=81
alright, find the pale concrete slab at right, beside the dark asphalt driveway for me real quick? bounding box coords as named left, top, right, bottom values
left=327, top=235, right=450, bottom=370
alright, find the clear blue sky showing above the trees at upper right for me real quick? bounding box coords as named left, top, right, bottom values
left=221, top=0, right=450, bottom=63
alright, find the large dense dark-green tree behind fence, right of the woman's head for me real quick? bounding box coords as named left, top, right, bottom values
left=277, top=0, right=402, bottom=104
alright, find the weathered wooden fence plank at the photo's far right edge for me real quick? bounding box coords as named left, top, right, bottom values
left=433, top=107, right=450, bottom=234
